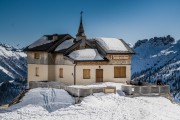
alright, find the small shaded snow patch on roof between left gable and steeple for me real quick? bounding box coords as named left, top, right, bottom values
left=55, top=39, right=74, bottom=51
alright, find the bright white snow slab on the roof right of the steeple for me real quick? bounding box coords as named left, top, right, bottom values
left=96, top=38, right=128, bottom=51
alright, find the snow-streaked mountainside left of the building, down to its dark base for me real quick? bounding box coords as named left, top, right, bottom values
left=0, top=43, right=27, bottom=105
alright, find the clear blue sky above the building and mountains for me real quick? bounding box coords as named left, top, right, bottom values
left=0, top=0, right=180, bottom=47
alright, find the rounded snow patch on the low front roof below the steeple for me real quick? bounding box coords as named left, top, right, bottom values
left=68, top=49, right=104, bottom=60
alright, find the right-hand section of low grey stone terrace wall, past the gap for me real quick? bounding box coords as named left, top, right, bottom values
left=121, top=85, right=170, bottom=95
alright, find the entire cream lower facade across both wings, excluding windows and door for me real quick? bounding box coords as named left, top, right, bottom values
left=28, top=64, right=131, bottom=85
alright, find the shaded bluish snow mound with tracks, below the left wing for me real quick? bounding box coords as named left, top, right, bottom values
left=2, top=88, right=75, bottom=112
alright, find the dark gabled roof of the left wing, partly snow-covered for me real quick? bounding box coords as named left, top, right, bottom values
left=24, top=34, right=73, bottom=52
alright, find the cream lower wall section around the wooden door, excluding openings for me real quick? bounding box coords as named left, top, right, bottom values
left=76, top=65, right=131, bottom=85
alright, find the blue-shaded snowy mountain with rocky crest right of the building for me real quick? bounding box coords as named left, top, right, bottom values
left=132, top=35, right=180, bottom=101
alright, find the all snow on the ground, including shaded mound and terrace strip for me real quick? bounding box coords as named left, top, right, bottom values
left=0, top=83, right=180, bottom=120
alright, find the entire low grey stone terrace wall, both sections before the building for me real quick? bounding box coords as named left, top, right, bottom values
left=29, top=81, right=170, bottom=97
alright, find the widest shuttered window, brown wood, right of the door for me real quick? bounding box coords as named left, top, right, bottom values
left=114, top=66, right=126, bottom=78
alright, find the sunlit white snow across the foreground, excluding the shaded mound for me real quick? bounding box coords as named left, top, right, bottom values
left=0, top=93, right=180, bottom=120
